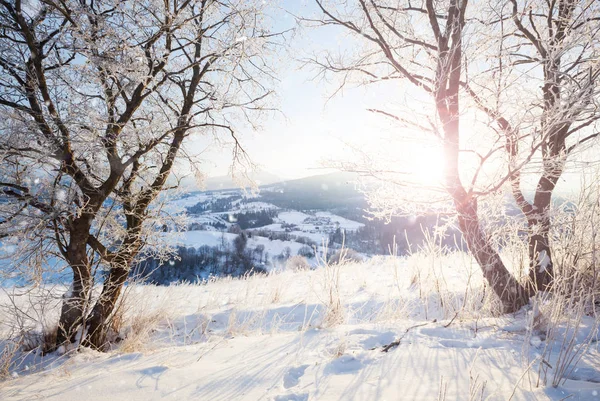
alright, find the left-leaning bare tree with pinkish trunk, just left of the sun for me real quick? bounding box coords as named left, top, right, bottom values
left=305, top=0, right=528, bottom=312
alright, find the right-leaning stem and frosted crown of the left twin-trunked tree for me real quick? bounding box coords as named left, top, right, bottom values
left=83, top=2, right=279, bottom=347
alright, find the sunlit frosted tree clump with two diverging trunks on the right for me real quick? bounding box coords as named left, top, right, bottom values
left=305, top=0, right=600, bottom=311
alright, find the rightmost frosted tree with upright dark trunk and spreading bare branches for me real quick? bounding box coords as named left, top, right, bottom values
left=464, top=0, right=600, bottom=291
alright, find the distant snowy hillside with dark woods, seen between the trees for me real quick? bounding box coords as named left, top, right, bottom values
left=155, top=173, right=460, bottom=284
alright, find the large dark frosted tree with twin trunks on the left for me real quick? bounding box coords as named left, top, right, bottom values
left=0, top=0, right=278, bottom=348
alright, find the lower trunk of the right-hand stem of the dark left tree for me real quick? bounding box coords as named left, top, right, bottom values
left=83, top=267, right=129, bottom=351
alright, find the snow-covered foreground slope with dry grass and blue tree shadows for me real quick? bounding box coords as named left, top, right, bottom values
left=0, top=253, right=600, bottom=401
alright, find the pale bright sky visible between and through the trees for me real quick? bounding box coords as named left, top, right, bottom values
left=194, top=0, right=596, bottom=197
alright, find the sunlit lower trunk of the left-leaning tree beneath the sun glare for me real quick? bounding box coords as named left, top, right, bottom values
left=456, top=199, right=529, bottom=313
